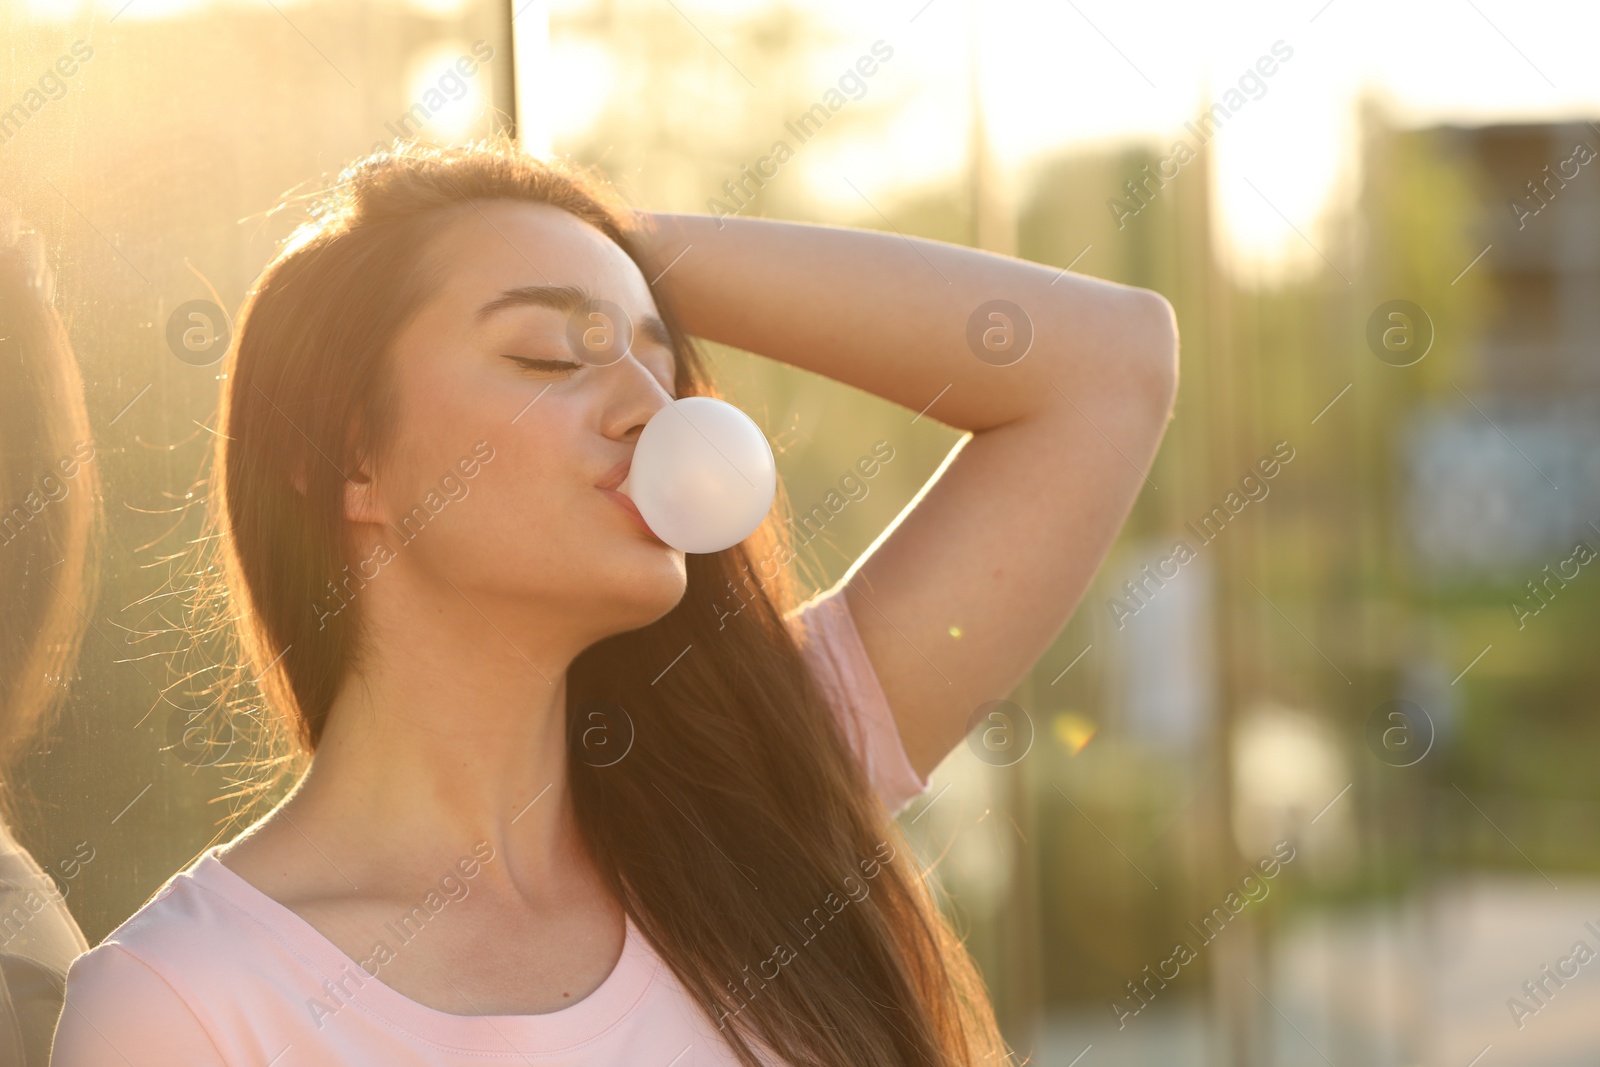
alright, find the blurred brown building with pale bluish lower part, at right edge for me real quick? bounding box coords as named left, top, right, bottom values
left=1406, top=122, right=1600, bottom=585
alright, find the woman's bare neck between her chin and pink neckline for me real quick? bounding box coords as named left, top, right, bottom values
left=283, top=566, right=595, bottom=888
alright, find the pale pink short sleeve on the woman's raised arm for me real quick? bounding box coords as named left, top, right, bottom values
left=784, top=581, right=928, bottom=814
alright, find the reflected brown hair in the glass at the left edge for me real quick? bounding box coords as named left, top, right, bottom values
left=0, top=202, right=101, bottom=819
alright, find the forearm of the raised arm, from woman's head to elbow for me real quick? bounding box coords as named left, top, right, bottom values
left=637, top=214, right=1174, bottom=432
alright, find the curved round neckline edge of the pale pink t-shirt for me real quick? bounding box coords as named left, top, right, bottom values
left=189, top=845, right=661, bottom=1054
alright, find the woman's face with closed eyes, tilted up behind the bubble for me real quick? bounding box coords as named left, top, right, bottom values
left=352, top=200, right=686, bottom=651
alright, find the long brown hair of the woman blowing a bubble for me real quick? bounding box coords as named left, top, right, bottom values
left=193, top=138, right=1005, bottom=1067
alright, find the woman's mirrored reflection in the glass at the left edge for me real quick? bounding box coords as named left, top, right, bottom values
left=0, top=200, right=99, bottom=1067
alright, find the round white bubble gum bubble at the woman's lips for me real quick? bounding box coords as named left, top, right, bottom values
left=618, top=397, right=778, bottom=553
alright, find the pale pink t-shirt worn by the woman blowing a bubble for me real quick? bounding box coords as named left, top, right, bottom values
left=51, top=584, right=928, bottom=1067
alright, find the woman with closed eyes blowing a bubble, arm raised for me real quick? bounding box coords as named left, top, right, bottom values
left=56, top=142, right=1176, bottom=1067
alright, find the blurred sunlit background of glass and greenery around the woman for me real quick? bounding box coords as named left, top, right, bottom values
left=0, top=0, right=1600, bottom=1067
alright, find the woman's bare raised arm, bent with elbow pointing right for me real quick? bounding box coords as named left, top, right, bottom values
left=640, top=214, right=1178, bottom=776
